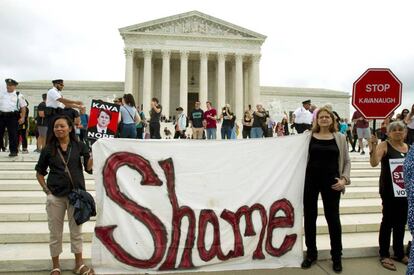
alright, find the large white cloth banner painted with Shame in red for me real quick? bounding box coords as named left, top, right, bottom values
left=92, top=135, right=308, bottom=274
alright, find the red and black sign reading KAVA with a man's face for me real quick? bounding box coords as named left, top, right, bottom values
left=87, top=100, right=120, bottom=139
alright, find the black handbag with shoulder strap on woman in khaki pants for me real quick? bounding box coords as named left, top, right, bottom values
left=58, top=149, right=96, bottom=225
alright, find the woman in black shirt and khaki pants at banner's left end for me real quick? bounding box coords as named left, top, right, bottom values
left=35, top=115, right=94, bottom=275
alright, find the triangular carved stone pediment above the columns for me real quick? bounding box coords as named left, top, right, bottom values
left=119, top=11, right=266, bottom=40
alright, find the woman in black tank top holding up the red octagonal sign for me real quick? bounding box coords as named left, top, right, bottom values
left=370, top=121, right=409, bottom=270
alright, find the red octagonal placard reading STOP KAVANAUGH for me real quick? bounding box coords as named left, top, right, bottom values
left=352, top=69, right=402, bottom=119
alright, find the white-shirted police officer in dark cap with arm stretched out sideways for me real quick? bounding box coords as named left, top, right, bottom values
left=45, top=79, right=83, bottom=136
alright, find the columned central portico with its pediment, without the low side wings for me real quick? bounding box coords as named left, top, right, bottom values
left=119, top=11, right=266, bottom=121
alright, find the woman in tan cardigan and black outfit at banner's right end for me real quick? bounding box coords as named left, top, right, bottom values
left=302, top=107, right=351, bottom=273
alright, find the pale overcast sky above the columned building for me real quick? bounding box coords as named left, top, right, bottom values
left=0, top=0, right=414, bottom=112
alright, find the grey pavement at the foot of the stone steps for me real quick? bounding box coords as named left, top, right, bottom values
left=0, top=257, right=406, bottom=275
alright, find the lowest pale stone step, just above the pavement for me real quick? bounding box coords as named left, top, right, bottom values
left=0, top=232, right=411, bottom=274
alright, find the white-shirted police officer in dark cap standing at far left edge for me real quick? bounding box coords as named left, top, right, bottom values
left=0, top=78, right=27, bottom=157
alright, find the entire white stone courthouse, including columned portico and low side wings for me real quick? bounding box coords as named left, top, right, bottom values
left=18, top=11, right=350, bottom=121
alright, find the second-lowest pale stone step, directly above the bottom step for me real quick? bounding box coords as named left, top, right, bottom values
left=0, top=213, right=388, bottom=243
